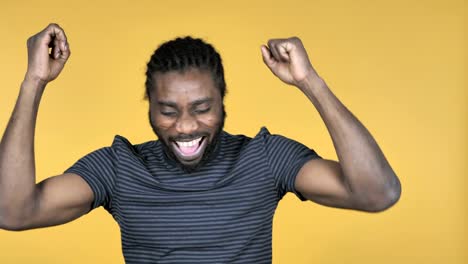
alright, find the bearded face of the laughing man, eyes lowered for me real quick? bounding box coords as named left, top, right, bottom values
left=149, top=69, right=224, bottom=170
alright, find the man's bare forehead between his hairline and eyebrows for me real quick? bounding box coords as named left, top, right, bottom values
left=153, top=69, right=219, bottom=103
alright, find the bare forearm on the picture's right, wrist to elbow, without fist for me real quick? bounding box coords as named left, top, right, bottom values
left=299, top=75, right=401, bottom=204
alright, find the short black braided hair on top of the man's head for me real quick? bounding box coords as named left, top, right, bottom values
left=145, top=37, right=226, bottom=99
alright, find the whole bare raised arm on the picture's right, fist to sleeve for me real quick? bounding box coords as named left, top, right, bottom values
left=261, top=37, right=401, bottom=212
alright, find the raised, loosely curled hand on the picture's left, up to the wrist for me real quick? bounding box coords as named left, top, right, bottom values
left=25, top=24, right=70, bottom=85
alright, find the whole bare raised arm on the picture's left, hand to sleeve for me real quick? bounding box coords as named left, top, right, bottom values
left=0, top=24, right=94, bottom=230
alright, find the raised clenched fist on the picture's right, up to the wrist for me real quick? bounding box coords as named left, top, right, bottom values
left=261, top=37, right=318, bottom=88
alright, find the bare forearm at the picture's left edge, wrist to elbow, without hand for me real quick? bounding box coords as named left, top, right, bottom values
left=0, top=80, right=45, bottom=221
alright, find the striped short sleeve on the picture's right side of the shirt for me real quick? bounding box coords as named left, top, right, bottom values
left=260, top=128, right=321, bottom=201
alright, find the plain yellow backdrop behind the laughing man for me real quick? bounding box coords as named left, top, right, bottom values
left=0, top=0, right=468, bottom=264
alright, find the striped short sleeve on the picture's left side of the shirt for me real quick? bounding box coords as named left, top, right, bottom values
left=65, top=147, right=116, bottom=210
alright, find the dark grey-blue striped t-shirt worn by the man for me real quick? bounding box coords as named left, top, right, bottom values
left=66, top=128, right=320, bottom=264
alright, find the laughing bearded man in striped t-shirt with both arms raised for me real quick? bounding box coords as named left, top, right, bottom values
left=0, top=24, right=401, bottom=263
